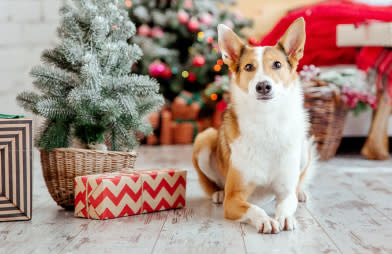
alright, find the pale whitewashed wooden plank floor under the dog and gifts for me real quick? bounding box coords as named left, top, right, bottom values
left=0, top=146, right=392, bottom=254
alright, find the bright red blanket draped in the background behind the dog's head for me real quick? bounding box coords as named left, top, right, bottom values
left=260, top=0, right=392, bottom=68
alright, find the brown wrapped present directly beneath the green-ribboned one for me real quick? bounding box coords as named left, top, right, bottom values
left=171, top=119, right=203, bottom=144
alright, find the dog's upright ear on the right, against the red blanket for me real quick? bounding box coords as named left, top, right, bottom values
left=277, top=17, right=306, bottom=70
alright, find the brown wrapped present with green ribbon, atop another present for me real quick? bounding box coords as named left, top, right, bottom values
left=171, top=91, right=204, bottom=120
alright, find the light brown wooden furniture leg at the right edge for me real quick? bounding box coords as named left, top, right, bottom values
left=361, top=92, right=392, bottom=160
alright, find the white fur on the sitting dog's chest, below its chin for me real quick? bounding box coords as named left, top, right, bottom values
left=230, top=83, right=307, bottom=189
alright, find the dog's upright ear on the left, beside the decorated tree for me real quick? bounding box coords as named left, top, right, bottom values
left=218, top=24, right=245, bottom=72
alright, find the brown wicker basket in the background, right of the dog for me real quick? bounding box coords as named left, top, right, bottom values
left=304, top=86, right=348, bottom=161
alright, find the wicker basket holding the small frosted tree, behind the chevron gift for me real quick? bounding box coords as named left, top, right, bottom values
left=40, top=148, right=137, bottom=209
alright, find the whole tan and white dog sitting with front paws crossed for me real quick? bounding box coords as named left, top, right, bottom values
left=193, top=18, right=317, bottom=233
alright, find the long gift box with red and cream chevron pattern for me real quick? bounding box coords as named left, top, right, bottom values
left=75, top=169, right=186, bottom=220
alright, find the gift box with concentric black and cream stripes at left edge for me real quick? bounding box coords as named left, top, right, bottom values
left=0, top=114, right=32, bottom=222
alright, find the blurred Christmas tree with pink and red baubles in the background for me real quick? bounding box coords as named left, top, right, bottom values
left=125, top=0, right=250, bottom=101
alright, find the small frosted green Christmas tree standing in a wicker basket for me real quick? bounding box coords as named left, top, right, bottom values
left=17, top=0, right=163, bottom=151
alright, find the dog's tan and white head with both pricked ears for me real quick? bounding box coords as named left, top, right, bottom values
left=218, top=18, right=306, bottom=102
